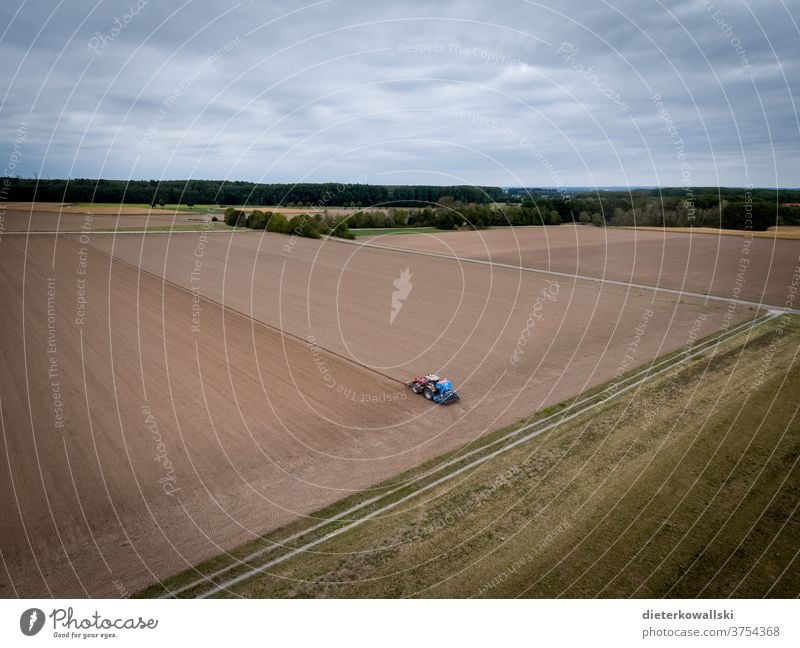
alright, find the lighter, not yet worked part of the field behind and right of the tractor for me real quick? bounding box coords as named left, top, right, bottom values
left=78, top=232, right=755, bottom=418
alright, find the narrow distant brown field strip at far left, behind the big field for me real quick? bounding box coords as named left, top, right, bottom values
left=3, top=209, right=214, bottom=232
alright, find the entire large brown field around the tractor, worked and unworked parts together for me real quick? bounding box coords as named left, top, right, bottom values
left=0, top=232, right=753, bottom=596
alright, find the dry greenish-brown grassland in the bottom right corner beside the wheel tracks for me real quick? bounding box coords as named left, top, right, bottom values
left=225, top=317, right=800, bottom=599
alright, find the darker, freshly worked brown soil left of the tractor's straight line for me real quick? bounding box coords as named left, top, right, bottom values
left=0, top=236, right=438, bottom=597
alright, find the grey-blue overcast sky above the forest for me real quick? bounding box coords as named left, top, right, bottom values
left=0, top=0, right=800, bottom=187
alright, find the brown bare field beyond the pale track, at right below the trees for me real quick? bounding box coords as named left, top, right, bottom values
left=359, top=225, right=800, bottom=305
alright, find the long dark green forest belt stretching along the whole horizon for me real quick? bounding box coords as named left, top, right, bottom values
left=4, top=178, right=800, bottom=230
